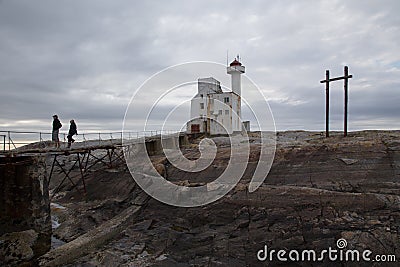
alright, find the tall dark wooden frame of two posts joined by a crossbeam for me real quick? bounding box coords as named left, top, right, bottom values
left=320, top=66, right=353, bottom=137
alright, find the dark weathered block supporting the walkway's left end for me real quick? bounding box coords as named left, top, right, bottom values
left=0, top=156, right=51, bottom=265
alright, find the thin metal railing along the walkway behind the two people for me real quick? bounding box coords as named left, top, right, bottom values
left=0, top=130, right=179, bottom=151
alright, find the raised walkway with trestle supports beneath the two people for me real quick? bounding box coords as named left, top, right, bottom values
left=0, top=132, right=185, bottom=198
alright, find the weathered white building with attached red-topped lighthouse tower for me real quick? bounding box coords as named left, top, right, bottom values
left=187, top=58, right=249, bottom=135
